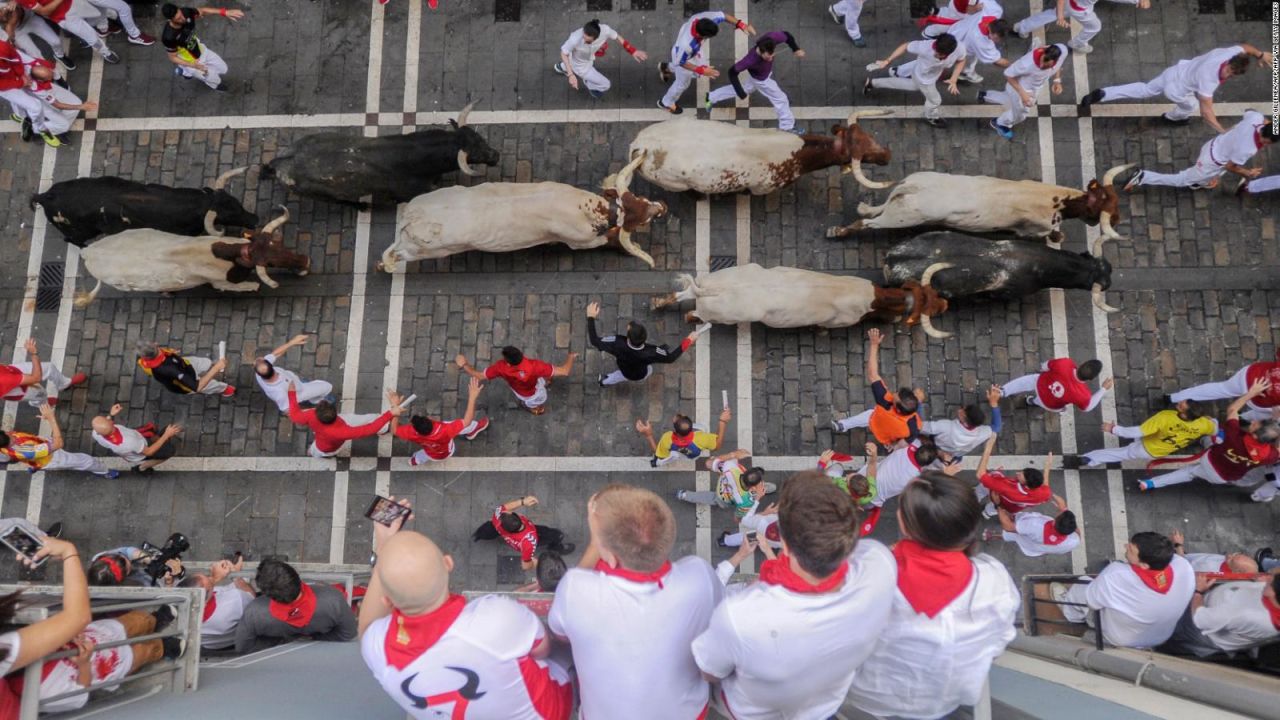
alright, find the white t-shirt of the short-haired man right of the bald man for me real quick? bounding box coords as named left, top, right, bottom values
left=547, top=556, right=724, bottom=720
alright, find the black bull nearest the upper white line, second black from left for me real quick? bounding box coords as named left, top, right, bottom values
left=262, top=102, right=498, bottom=204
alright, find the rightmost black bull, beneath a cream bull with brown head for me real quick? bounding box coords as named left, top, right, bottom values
left=884, top=231, right=1116, bottom=335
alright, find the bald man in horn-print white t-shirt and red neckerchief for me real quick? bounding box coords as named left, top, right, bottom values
left=360, top=520, right=573, bottom=720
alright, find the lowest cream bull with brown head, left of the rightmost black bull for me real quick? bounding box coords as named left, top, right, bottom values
left=650, top=263, right=948, bottom=337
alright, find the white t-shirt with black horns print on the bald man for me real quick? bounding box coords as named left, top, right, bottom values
left=360, top=594, right=568, bottom=720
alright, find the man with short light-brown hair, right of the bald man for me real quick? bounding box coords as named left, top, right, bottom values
left=545, top=484, right=724, bottom=720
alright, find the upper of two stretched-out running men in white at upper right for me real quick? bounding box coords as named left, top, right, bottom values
left=1080, top=42, right=1271, bottom=133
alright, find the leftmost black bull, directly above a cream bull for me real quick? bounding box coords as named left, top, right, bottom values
left=31, top=168, right=259, bottom=247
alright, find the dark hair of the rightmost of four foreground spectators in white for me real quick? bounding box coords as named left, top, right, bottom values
left=897, top=471, right=982, bottom=550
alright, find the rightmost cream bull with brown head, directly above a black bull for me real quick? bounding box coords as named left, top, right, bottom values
left=827, top=165, right=1133, bottom=242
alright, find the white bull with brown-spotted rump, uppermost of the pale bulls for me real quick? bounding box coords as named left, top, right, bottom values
left=616, top=110, right=891, bottom=195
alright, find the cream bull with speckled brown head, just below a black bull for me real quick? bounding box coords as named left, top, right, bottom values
left=376, top=155, right=667, bottom=273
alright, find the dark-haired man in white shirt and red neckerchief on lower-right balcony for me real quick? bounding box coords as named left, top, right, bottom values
left=1050, top=532, right=1196, bottom=648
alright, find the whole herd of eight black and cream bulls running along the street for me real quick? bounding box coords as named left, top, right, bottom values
left=31, top=105, right=1128, bottom=338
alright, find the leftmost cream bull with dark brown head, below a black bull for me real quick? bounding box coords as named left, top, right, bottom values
left=76, top=208, right=311, bottom=307
